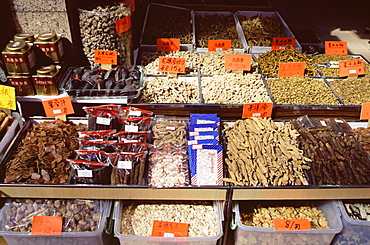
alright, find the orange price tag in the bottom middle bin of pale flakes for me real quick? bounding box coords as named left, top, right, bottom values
left=152, top=220, right=189, bottom=237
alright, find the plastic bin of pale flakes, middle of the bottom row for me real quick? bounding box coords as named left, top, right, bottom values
left=113, top=201, right=223, bottom=245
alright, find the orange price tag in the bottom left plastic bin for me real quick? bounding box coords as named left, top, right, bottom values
left=31, top=216, right=63, bottom=236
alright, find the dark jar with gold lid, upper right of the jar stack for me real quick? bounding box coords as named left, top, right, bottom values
left=34, top=32, right=64, bottom=64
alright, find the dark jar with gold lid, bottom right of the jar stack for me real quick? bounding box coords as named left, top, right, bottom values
left=32, top=65, right=60, bottom=95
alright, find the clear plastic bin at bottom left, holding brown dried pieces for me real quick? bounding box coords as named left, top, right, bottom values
left=0, top=199, right=112, bottom=245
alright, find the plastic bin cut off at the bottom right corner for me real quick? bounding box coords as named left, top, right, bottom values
left=332, top=200, right=370, bottom=244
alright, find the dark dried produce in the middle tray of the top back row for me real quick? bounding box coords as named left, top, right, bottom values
left=195, top=13, right=243, bottom=49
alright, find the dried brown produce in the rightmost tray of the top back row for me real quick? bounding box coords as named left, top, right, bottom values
left=238, top=15, right=284, bottom=47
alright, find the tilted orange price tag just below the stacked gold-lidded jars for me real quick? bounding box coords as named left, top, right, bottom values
left=42, top=96, right=74, bottom=117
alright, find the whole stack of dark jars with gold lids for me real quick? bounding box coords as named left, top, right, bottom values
left=2, top=31, right=64, bottom=96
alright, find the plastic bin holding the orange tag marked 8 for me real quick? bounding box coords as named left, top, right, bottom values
left=234, top=201, right=342, bottom=245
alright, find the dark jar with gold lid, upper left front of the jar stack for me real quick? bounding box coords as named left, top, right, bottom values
left=2, top=41, right=36, bottom=74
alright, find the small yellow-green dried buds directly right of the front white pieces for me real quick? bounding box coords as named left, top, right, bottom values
left=266, top=76, right=340, bottom=105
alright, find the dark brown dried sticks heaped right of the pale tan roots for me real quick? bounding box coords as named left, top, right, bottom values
left=291, top=116, right=370, bottom=185
